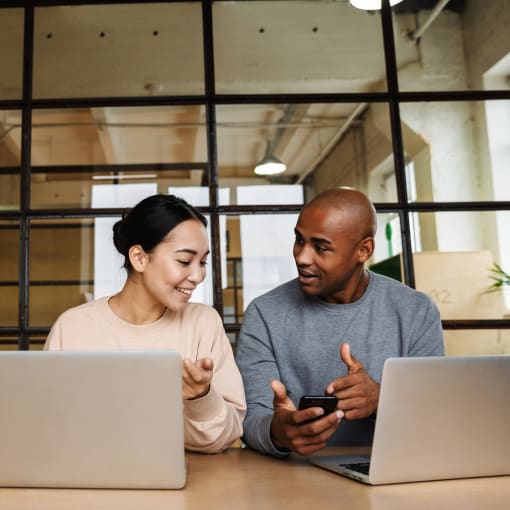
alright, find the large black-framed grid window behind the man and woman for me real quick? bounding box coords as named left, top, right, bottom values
left=0, top=0, right=510, bottom=353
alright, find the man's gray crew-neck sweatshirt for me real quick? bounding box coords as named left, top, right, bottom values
left=236, top=272, right=444, bottom=456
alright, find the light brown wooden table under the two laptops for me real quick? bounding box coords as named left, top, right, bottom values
left=0, top=448, right=510, bottom=510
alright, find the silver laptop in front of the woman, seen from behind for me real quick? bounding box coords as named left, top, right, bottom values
left=0, top=351, right=186, bottom=489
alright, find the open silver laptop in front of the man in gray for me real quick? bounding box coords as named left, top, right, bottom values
left=310, top=356, right=510, bottom=485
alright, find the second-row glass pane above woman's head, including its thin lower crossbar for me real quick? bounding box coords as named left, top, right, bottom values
left=31, top=106, right=209, bottom=208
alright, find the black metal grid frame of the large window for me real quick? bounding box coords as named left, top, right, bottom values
left=0, top=0, right=510, bottom=350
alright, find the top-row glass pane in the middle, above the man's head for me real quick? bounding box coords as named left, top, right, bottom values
left=213, top=0, right=386, bottom=94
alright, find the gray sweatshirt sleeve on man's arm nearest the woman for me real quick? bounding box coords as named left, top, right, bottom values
left=236, top=301, right=288, bottom=457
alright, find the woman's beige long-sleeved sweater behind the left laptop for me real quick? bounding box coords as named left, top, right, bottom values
left=44, top=297, right=246, bottom=453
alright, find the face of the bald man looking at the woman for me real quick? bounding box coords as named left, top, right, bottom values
left=293, top=206, right=364, bottom=303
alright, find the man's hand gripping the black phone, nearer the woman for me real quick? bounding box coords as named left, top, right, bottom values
left=271, top=380, right=343, bottom=455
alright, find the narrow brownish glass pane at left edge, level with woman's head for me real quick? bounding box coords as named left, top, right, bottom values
left=0, top=221, right=20, bottom=326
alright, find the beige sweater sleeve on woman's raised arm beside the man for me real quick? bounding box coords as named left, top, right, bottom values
left=184, top=313, right=246, bottom=453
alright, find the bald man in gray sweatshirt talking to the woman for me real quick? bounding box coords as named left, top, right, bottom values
left=236, top=188, right=444, bottom=457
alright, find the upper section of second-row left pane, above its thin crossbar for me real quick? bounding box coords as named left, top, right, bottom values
left=32, top=106, right=207, bottom=165
